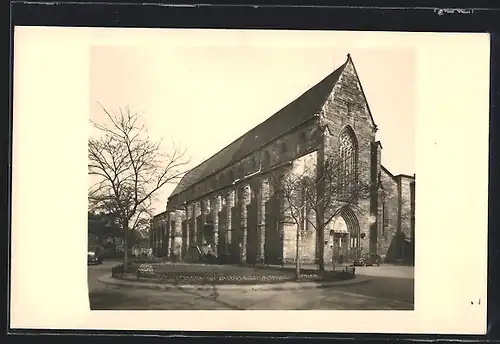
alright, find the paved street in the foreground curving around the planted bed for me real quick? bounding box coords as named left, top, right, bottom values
left=88, top=261, right=414, bottom=310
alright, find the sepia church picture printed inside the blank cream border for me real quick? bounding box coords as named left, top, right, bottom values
left=88, top=41, right=415, bottom=310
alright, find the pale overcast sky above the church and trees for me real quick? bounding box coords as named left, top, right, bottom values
left=89, top=35, right=415, bottom=213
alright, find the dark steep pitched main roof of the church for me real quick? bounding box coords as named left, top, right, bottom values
left=170, top=58, right=349, bottom=197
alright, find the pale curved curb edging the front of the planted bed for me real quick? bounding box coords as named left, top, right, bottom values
left=97, top=275, right=371, bottom=291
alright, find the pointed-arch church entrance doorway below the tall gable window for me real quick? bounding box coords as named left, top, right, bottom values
left=325, top=208, right=360, bottom=263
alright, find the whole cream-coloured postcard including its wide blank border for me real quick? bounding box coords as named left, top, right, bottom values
left=9, top=26, right=490, bottom=335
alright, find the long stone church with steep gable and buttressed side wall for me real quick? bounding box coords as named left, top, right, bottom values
left=152, top=55, right=415, bottom=264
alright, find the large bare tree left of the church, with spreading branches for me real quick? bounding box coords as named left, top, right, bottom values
left=88, top=107, right=189, bottom=269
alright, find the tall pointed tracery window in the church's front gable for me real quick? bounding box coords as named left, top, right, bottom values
left=339, top=128, right=357, bottom=199
